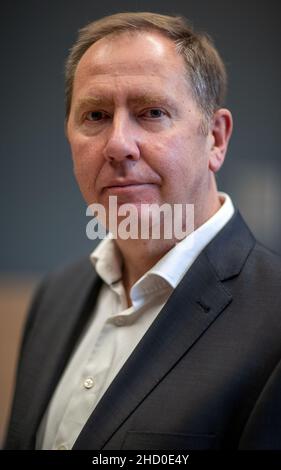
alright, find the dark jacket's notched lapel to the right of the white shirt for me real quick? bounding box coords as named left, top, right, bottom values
left=74, top=210, right=254, bottom=450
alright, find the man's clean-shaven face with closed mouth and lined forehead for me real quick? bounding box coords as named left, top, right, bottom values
left=67, top=32, right=212, bottom=222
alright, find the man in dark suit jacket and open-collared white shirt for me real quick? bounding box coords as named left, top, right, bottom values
left=3, top=13, right=281, bottom=450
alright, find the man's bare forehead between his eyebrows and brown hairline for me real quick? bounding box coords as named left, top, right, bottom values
left=73, top=31, right=190, bottom=94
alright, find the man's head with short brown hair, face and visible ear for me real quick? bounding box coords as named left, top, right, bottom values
left=67, top=13, right=232, bottom=229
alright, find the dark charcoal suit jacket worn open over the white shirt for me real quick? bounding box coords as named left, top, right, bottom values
left=3, top=213, right=281, bottom=450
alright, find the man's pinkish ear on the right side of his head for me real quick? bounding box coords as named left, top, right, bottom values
left=209, top=108, right=233, bottom=173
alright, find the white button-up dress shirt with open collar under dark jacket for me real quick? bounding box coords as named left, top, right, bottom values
left=37, top=193, right=234, bottom=450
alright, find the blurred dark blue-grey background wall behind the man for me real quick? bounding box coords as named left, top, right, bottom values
left=0, top=0, right=281, bottom=446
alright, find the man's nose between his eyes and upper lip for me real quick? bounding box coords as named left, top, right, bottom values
left=103, top=111, right=140, bottom=163
